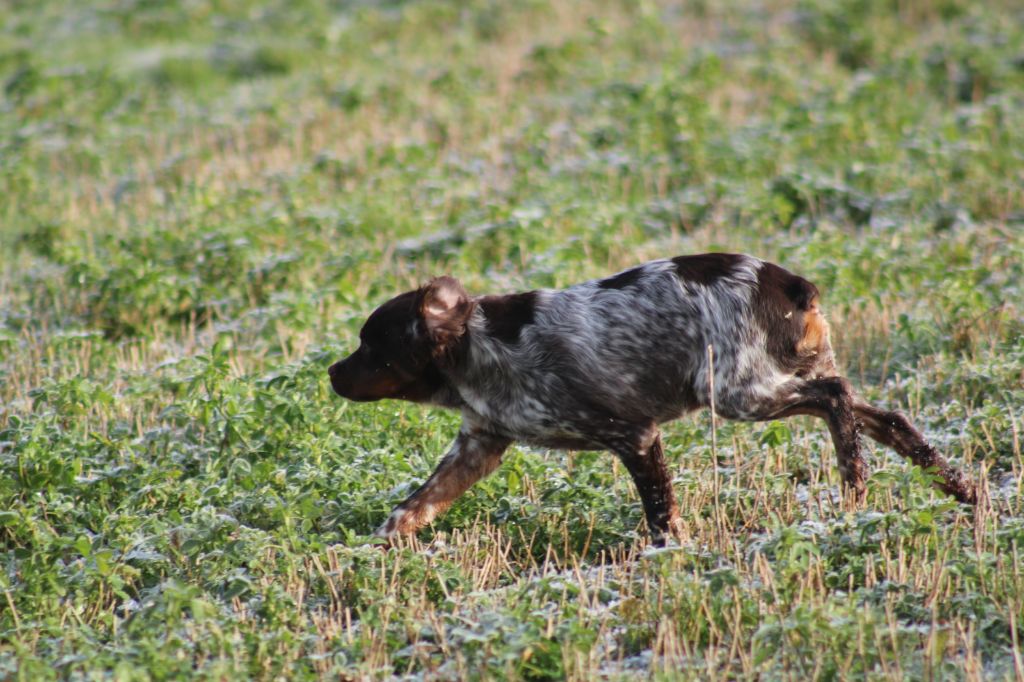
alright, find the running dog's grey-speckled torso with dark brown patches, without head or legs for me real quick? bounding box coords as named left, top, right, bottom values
left=456, top=254, right=831, bottom=439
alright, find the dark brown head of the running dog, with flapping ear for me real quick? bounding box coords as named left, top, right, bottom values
left=328, top=276, right=474, bottom=402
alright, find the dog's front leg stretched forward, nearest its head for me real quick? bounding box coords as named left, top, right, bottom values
left=376, top=424, right=512, bottom=538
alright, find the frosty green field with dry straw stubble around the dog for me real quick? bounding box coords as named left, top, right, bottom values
left=0, top=0, right=1024, bottom=680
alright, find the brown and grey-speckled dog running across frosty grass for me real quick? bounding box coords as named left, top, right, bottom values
left=329, top=253, right=976, bottom=546
